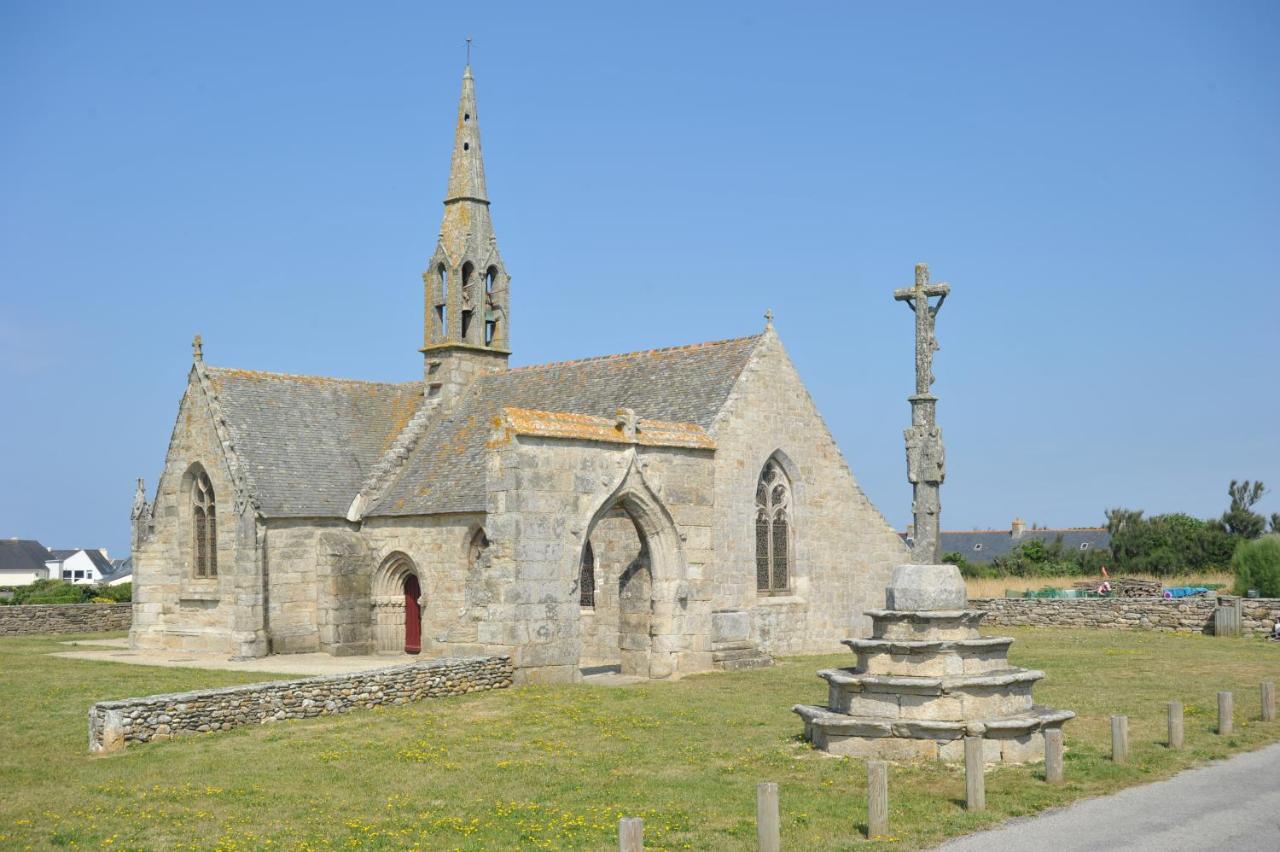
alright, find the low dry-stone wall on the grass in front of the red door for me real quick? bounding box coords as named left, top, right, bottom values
left=88, top=656, right=515, bottom=753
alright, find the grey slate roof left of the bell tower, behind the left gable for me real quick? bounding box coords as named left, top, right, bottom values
left=204, top=367, right=422, bottom=517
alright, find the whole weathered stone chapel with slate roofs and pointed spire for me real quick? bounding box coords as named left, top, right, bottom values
left=131, top=67, right=909, bottom=682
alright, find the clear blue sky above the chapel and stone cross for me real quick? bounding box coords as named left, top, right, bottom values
left=0, top=0, right=1280, bottom=555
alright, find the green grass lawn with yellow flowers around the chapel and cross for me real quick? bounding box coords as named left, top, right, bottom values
left=0, top=628, right=1280, bottom=849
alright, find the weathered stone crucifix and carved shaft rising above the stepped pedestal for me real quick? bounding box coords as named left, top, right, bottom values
left=893, top=264, right=951, bottom=565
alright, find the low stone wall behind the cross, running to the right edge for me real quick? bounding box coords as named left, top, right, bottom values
left=969, top=597, right=1280, bottom=636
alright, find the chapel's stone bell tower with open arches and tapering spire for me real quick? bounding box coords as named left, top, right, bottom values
left=421, top=64, right=511, bottom=397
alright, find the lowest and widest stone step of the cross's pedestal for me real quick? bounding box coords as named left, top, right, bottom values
left=791, top=704, right=1075, bottom=762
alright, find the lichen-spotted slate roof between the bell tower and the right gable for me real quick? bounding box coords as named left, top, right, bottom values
left=366, top=335, right=760, bottom=516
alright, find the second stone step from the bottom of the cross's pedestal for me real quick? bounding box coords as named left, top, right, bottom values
left=818, top=668, right=1044, bottom=722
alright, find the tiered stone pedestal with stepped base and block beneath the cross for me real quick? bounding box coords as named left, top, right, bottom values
left=792, top=565, right=1075, bottom=762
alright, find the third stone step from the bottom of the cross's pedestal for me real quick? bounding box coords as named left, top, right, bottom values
left=844, top=636, right=1014, bottom=677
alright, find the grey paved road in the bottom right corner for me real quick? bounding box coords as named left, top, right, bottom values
left=940, top=745, right=1280, bottom=852
